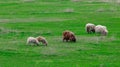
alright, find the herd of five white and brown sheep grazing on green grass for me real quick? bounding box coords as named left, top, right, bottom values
left=27, top=23, right=108, bottom=46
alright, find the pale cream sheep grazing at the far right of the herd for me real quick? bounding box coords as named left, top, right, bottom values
left=95, top=25, right=108, bottom=36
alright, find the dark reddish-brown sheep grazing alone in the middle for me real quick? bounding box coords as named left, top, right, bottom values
left=62, top=31, right=76, bottom=42
